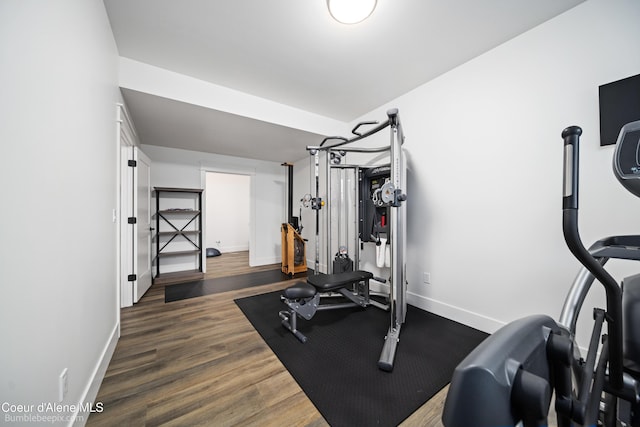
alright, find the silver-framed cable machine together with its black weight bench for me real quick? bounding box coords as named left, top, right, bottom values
left=280, top=109, right=406, bottom=371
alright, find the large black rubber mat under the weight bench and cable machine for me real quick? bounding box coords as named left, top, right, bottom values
left=235, top=292, right=487, bottom=427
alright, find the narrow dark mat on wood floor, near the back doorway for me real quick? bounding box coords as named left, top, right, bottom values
left=164, top=269, right=306, bottom=303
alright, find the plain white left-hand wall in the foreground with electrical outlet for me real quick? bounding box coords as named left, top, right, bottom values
left=0, top=0, right=119, bottom=424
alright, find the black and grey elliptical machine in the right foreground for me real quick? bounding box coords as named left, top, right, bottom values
left=442, top=121, right=640, bottom=427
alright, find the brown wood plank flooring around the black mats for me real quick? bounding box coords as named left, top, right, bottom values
left=87, top=253, right=446, bottom=427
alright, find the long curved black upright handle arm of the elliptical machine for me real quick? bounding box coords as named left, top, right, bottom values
left=562, top=126, right=623, bottom=389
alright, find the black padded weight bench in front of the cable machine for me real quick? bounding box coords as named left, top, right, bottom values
left=279, top=270, right=386, bottom=343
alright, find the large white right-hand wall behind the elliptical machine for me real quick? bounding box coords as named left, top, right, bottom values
left=296, top=0, right=640, bottom=348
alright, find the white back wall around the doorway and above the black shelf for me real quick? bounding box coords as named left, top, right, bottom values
left=141, top=144, right=285, bottom=266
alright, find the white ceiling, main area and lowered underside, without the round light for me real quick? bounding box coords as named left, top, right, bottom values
left=104, top=0, right=584, bottom=161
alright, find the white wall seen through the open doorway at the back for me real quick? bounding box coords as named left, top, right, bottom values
left=205, top=172, right=251, bottom=253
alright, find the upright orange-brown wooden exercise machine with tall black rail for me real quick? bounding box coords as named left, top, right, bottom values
left=280, top=163, right=307, bottom=276
